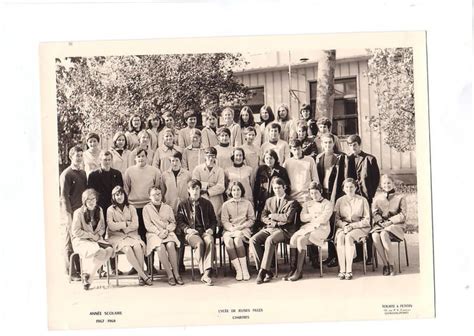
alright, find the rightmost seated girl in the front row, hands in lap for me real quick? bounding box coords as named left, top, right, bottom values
left=371, top=175, right=407, bottom=275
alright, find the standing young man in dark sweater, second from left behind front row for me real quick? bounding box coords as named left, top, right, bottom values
left=87, top=151, right=123, bottom=275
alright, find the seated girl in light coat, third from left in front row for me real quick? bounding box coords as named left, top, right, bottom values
left=143, top=187, right=184, bottom=286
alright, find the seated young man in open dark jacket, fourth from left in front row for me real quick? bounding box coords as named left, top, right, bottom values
left=176, top=179, right=217, bottom=286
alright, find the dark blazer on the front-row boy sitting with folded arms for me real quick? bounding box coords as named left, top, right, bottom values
left=262, top=195, right=299, bottom=234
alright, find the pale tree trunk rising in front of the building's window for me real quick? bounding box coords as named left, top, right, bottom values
left=316, top=50, right=336, bottom=122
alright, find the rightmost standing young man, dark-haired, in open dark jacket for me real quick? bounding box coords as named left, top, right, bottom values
left=345, top=134, right=380, bottom=265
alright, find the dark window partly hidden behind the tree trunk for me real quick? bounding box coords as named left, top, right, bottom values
left=309, top=78, right=359, bottom=137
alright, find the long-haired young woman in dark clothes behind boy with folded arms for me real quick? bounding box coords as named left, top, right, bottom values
left=253, top=149, right=290, bottom=219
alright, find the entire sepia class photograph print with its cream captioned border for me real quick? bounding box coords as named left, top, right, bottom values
left=40, top=32, right=435, bottom=330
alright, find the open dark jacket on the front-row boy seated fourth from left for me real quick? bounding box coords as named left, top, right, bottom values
left=175, top=197, right=217, bottom=237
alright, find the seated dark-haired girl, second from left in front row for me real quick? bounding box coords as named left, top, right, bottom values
left=107, top=186, right=152, bottom=286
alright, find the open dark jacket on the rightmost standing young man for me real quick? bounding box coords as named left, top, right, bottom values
left=344, top=152, right=380, bottom=204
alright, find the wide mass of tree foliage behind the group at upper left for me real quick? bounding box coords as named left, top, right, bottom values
left=56, top=53, right=248, bottom=162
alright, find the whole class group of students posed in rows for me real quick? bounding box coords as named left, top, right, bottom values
left=60, top=104, right=406, bottom=289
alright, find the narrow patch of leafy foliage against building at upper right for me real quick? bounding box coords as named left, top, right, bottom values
left=367, top=48, right=416, bottom=152
